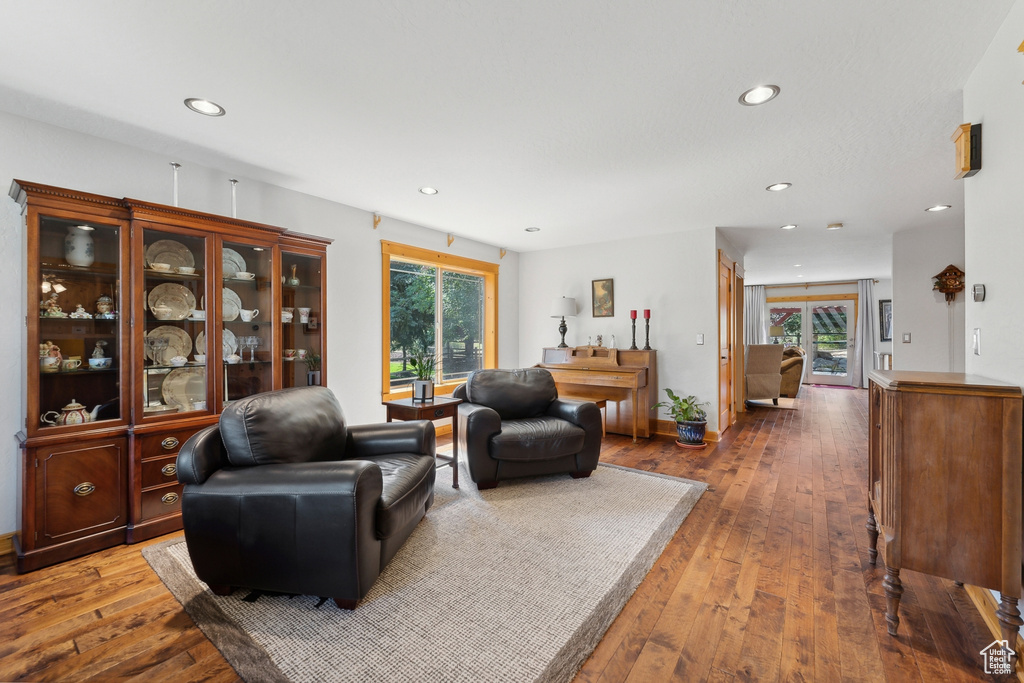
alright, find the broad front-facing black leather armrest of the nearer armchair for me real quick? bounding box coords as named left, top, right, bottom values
left=181, top=460, right=383, bottom=600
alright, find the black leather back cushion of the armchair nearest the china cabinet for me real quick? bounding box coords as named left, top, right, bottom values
left=220, top=386, right=347, bottom=467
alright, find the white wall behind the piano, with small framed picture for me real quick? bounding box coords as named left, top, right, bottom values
left=518, top=228, right=718, bottom=430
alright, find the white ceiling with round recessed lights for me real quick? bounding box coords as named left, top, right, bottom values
left=0, top=0, right=1013, bottom=284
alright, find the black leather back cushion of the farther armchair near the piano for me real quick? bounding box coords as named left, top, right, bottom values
left=466, top=368, right=558, bottom=421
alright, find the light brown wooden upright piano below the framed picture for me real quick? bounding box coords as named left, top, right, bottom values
left=537, top=346, right=657, bottom=441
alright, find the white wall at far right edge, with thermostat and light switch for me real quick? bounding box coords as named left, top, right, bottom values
left=964, top=0, right=1024, bottom=385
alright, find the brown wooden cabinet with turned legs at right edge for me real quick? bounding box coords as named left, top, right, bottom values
left=867, top=370, right=1024, bottom=646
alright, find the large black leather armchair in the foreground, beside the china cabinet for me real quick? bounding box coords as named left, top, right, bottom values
left=177, top=386, right=435, bottom=609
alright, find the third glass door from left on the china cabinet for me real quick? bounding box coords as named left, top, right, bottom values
left=220, top=240, right=275, bottom=404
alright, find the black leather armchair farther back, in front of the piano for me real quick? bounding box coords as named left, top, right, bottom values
left=453, top=368, right=601, bottom=489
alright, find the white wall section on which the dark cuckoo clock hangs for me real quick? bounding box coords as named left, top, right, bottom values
left=893, top=224, right=971, bottom=373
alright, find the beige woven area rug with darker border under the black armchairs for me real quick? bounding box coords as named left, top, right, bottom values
left=142, top=466, right=707, bottom=683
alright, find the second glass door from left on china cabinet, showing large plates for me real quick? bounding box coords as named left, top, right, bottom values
left=139, top=227, right=210, bottom=418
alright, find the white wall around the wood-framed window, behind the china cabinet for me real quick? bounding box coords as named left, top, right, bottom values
left=0, top=113, right=519, bottom=535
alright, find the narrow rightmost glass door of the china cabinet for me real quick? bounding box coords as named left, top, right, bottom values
left=281, top=251, right=324, bottom=387
